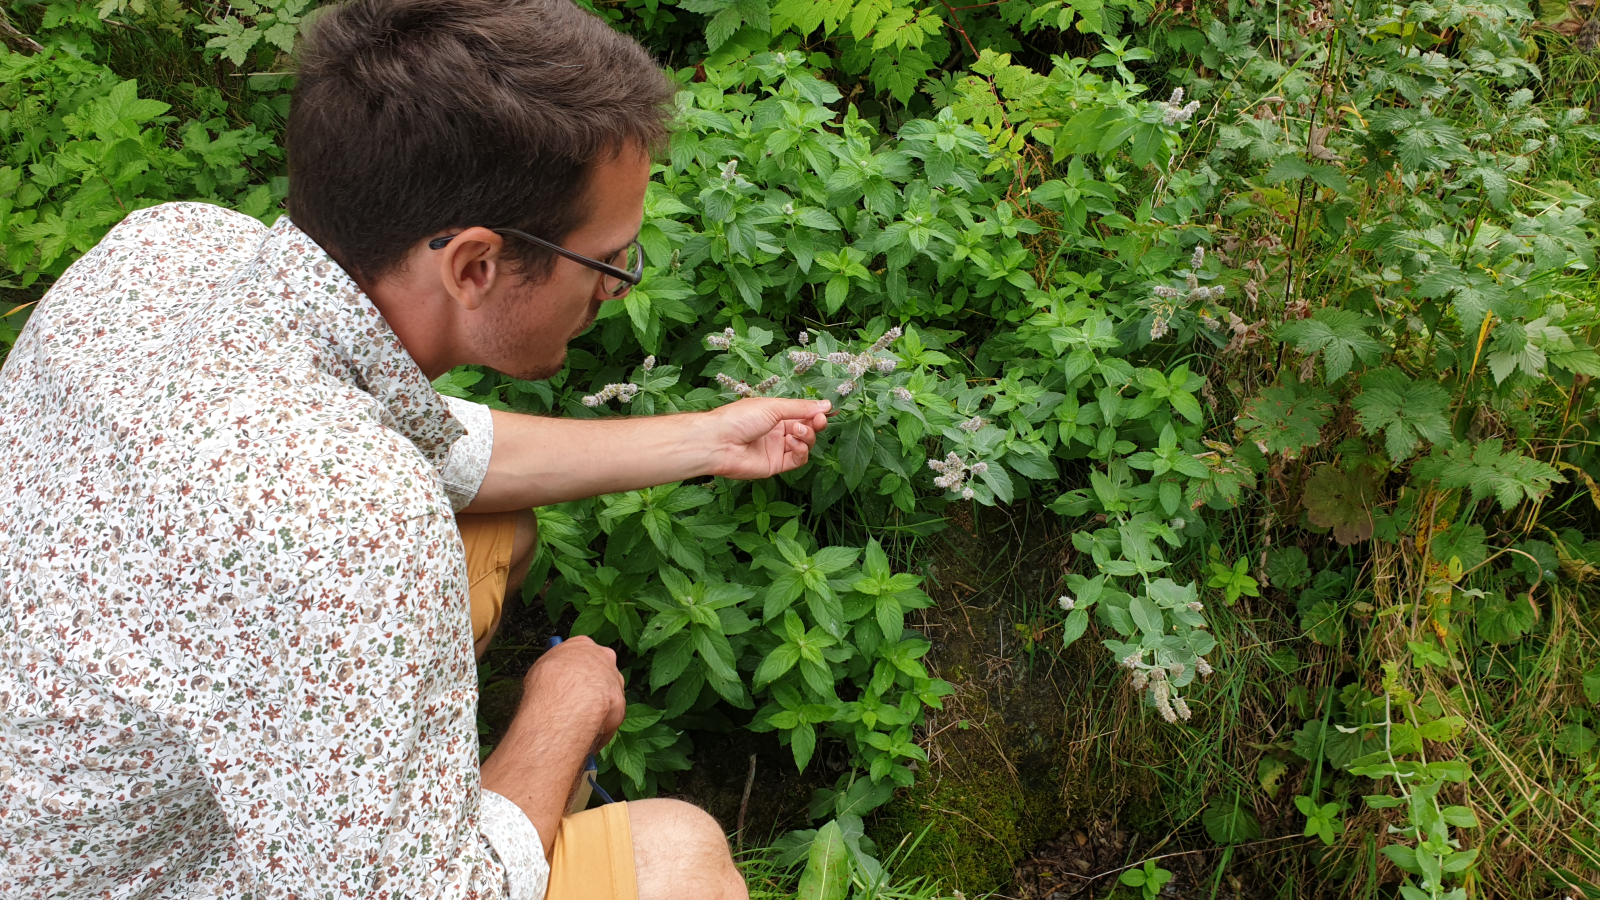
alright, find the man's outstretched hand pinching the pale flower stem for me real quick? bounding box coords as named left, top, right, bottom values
left=704, top=397, right=832, bottom=480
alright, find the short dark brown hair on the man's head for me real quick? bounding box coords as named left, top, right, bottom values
left=288, top=0, right=672, bottom=279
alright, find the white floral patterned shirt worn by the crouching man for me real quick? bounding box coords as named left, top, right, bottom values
left=0, top=203, right=549, bottom=900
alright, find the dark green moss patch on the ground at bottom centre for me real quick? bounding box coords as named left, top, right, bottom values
left=872, top=767, right=1066, bottom=895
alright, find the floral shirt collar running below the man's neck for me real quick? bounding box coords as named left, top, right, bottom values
left=256, top=216, right=466, bottom=466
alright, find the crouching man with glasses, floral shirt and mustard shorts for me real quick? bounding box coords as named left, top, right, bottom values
left=0, top=0, right=826, bottom=900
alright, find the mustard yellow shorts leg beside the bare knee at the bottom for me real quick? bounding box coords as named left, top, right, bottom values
left=544, top=802, right=638, bottom=900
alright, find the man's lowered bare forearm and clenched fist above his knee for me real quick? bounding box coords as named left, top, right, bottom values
left=478, top=637, right=627, bottom=855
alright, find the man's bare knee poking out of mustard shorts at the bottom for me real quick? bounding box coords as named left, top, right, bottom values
left=627, top=799, right=749, bottom=900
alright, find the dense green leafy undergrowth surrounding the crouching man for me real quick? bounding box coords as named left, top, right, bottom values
left=0, top=0, right=1600, bottom=900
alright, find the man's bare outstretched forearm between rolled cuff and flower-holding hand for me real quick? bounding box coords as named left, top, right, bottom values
left=464, top=410, right=715, bottom=512
